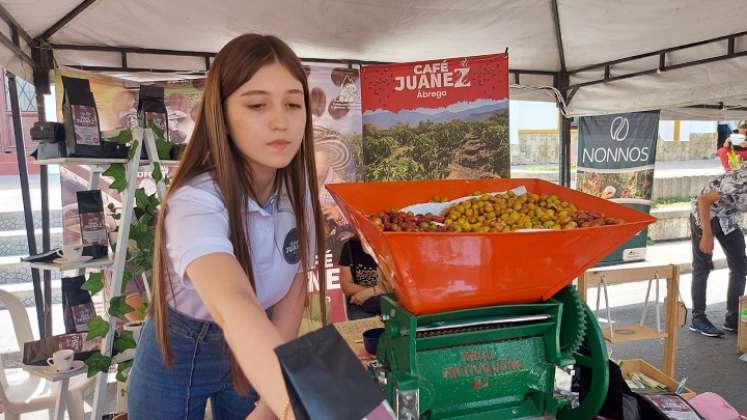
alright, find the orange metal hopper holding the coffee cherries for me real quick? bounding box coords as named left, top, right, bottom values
left=327, top=179, right=656, bottom=315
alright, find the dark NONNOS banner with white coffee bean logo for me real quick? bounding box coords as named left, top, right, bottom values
left=576, top=111, right=659, bottom=265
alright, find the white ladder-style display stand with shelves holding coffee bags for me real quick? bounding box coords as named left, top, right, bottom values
left=23, top=128, right=171, bottom=419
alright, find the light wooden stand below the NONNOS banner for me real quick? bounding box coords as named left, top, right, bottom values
left=578, top=264, right=680, bottom=377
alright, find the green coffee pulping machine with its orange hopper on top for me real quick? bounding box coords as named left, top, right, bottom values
left=327, top=179, right=655, bottom=420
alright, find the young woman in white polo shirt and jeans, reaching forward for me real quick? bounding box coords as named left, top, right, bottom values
left=128, top=34, right=325, bottom=420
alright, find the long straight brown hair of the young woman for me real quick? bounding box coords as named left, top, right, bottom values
left=150, top=34, right=327, bottom=389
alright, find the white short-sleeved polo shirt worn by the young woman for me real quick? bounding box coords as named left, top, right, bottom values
left=165, top=174, right=315, bottom=321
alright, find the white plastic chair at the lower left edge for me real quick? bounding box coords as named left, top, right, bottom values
left=0, top=290, right=95, bottom=420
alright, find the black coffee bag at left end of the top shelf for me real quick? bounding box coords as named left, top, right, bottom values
left=62, top=76, right=103, bottom=157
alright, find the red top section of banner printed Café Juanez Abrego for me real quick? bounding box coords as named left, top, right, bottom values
left=361, top=54, right=508, bottom=112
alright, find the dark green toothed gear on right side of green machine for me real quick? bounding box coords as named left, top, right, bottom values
left=553, top=285, right=588, bottom=357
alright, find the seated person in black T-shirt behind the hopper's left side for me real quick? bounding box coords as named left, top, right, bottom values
left=339, top=236, right=386, bottom=320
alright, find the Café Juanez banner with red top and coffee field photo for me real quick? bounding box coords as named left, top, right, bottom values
left=361, top=54, right=510, bottom=181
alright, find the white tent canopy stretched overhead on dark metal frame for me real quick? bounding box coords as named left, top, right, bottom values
left=0, top=0, right=747, bottom=118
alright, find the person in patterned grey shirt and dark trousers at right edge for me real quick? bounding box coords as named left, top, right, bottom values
left=690, top=167, right=747, bottom=337
